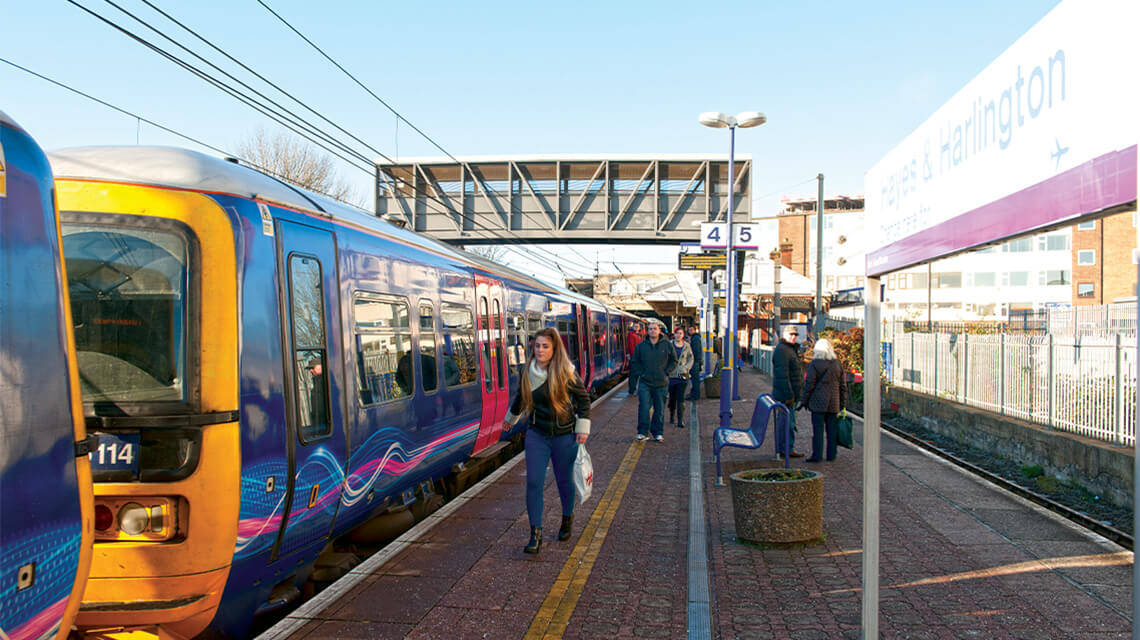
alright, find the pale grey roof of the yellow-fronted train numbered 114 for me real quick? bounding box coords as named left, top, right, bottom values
left=44, top=144, right=620, bottom=308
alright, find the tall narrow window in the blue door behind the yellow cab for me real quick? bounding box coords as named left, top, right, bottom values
left=288, top=253, right=333, bottom=443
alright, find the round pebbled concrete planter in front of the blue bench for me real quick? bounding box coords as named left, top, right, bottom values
left=730, top=469, right=823, bottom=542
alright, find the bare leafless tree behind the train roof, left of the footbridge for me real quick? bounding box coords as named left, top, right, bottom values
left=237, top=127, right=359, bottom=204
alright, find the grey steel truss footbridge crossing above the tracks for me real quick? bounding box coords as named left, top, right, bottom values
left=376, top=155, right=752, bottom=245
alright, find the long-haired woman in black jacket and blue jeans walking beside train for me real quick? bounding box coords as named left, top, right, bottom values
left=504, top=327, right=589, bottom=553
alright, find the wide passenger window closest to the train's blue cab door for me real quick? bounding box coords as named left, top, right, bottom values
left=352, top=291, right=416, bottom=406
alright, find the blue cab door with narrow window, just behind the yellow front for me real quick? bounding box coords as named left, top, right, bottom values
left=272, top=220, right=347, bottom=560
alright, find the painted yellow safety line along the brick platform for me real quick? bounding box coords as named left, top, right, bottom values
left=523, top=443, right=645, bottom=640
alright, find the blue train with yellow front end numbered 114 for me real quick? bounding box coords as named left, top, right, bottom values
left=49, top=146, right=635, bottom=638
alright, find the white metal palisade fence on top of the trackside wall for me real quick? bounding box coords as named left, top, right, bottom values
left=885, top=332, right=1137, bottom=446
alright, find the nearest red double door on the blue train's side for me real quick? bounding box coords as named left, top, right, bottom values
left=473, top=274, right=511, bottom=453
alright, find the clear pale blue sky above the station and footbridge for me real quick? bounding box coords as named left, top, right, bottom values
left=0, top=0, right=1058, bottom=280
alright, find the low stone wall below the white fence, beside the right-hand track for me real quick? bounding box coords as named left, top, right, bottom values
left=887, top=387, right=1134, bottom=507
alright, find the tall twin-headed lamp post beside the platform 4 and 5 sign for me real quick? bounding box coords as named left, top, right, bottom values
left=697, top=111, right=768, bottom=427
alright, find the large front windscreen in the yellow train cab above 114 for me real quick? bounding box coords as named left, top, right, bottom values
left=63, top=221, right=195, bottom=406
